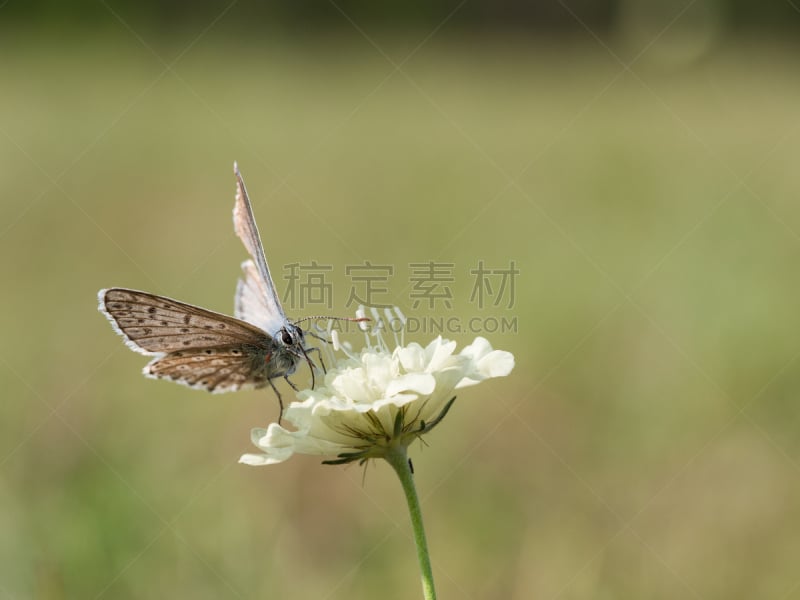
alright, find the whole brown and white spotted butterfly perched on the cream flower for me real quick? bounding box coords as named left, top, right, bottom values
left=98, top=163, right=330, bottom=422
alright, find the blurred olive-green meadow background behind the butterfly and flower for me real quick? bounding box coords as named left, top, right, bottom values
left=0, top=0, right=800, bottom=600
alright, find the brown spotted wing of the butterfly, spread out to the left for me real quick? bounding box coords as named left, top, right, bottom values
left=98, top=288, right=273, bottom=392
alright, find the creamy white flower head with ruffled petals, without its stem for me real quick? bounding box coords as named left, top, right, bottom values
left=239, top=314, right=514, bottom=465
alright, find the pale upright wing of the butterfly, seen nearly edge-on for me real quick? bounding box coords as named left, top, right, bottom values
left=233, top=163, right=288, bottom=335
